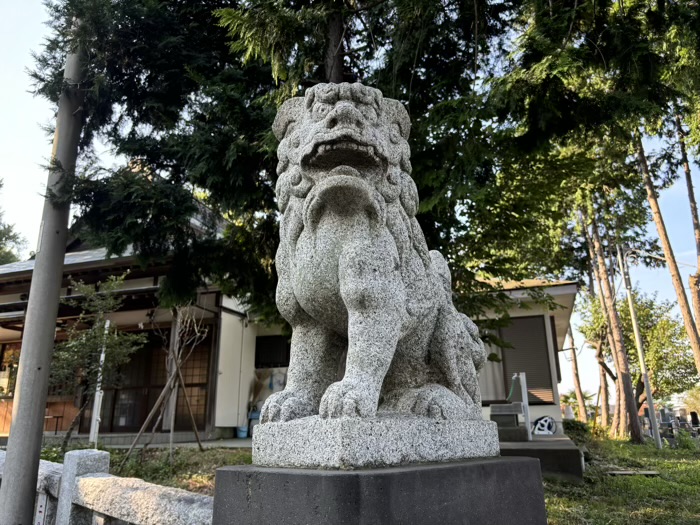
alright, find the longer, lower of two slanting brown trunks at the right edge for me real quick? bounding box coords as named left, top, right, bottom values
left=634, top=132, right=700, bottom=372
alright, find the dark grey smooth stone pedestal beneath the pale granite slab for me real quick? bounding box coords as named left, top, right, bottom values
left=212, top=457, right=547, bottom=525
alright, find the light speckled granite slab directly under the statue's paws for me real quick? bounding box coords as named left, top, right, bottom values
left=253, top=413, right=499, bottom=469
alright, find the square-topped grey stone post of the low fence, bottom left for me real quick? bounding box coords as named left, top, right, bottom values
left=56, top=450, right=109, bottom=525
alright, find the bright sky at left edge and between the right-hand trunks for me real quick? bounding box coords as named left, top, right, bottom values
left=0, top=1, right=698, bottom=400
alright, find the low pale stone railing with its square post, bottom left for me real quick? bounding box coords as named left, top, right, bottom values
left=0, top=450, right=213, bottom=525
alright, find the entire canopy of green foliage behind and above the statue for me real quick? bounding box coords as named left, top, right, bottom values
left=33, top=0, right=700, bottom=326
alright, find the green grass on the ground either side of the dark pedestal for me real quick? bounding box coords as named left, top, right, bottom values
left=45, top=439, right=700, bottom=525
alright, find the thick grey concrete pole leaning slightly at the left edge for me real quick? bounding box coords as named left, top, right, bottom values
left=0, top=34, right=84, bottom=525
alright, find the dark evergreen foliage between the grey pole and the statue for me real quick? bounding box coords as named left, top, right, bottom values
left=32, top=0, right=277, bottom=311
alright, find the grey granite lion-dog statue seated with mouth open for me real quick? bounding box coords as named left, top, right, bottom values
left=261, top=84, right=486, bottom=423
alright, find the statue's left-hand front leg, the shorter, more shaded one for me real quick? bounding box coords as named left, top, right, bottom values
left=260, top=319, right=345, bottom=423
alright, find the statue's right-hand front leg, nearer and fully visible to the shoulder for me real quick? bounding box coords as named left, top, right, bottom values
left=319, top=245, right=406, bottom=418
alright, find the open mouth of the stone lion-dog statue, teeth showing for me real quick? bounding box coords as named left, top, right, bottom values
left=301, top=133, right=387, bottom=172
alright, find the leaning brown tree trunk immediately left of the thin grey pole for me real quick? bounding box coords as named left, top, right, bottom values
left=591, top=212, right=644, bottom=443
